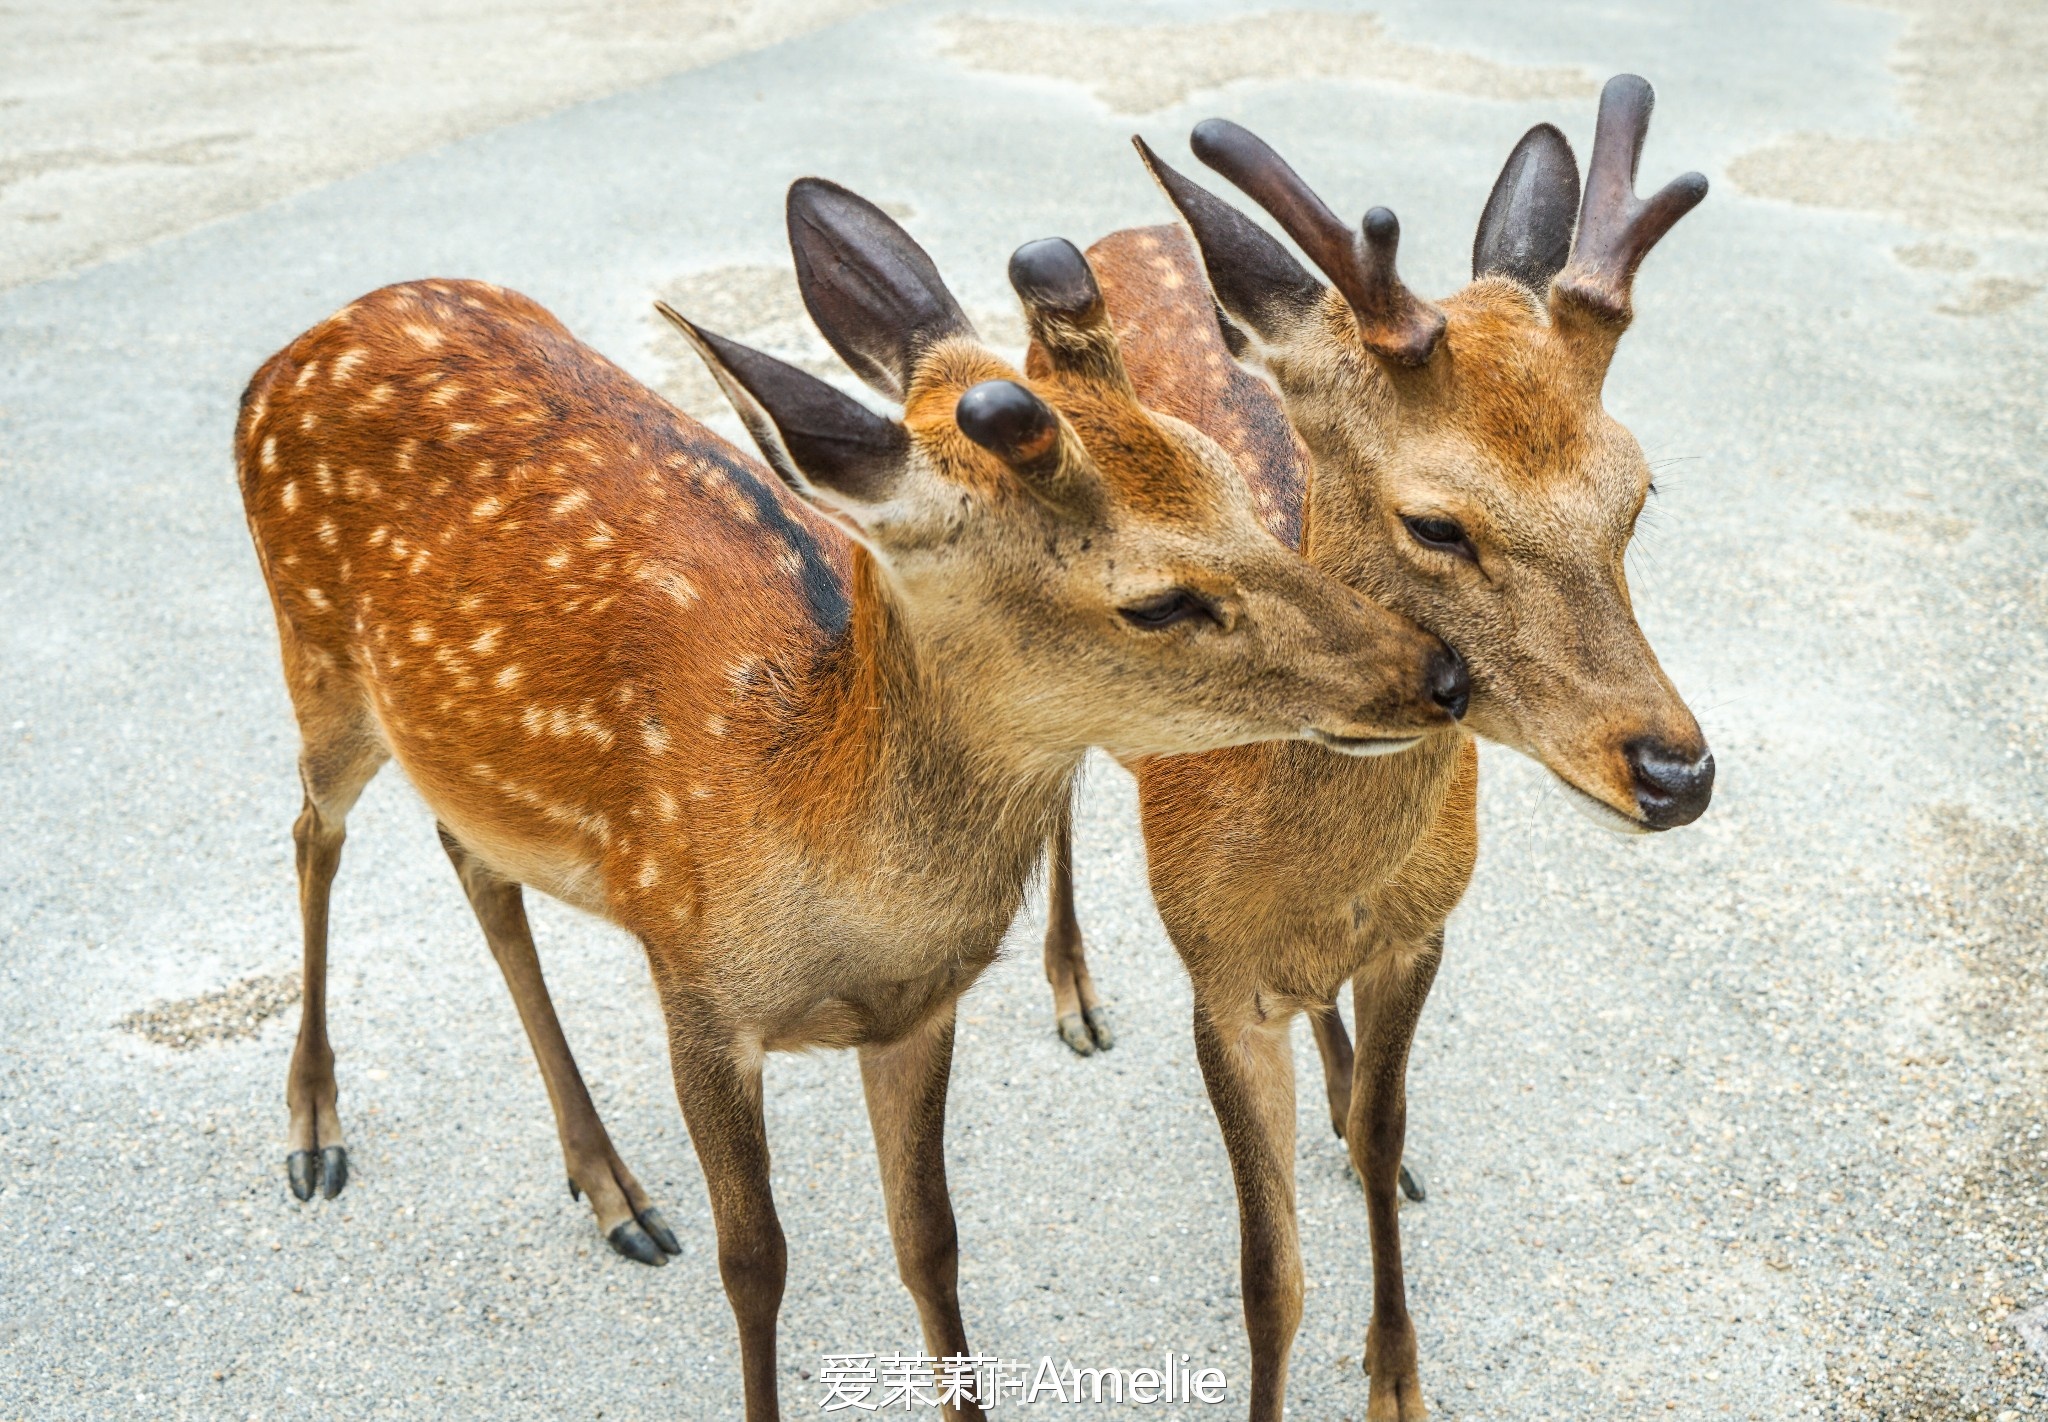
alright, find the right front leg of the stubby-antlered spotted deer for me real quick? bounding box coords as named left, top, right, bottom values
left=860, top=1004, right=983, bottom=1422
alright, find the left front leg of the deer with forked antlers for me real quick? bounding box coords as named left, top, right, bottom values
left=1194, top=996, right=1303, bottom=1422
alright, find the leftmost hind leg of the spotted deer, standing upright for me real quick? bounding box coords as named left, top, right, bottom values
left=285, top=692, right=389, bottom=1201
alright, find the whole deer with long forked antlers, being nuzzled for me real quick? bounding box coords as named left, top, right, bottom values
left=1047, top=76, right=1714, bottom=1422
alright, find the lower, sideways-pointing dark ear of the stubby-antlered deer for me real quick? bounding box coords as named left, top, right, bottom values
left=655, top=301, right=909, bottom=516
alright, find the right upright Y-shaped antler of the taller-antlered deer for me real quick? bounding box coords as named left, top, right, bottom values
left=1556, top=74, right=1706, bottom=322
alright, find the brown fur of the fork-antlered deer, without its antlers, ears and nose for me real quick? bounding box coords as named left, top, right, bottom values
left=1047, top=227, right=1704, bottom=1422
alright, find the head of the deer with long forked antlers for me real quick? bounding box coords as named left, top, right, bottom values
left=1139, top=76, right=1714, bottom=830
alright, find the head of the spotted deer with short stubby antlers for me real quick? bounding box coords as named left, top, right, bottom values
left=664, top=178, right=1464, bottom=770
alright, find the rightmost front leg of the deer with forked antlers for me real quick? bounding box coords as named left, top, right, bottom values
left=1346, top=928, right=1444, bottom=1422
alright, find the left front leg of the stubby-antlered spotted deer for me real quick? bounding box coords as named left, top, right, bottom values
left=657, top=987, right=788, bottom=1422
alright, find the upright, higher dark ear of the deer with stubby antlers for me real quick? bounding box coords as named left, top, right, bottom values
left=788, top=178, right=975, bottom=400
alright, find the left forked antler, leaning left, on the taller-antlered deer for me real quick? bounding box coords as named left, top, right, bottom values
left=1190, top=119, right=1444, bottom=365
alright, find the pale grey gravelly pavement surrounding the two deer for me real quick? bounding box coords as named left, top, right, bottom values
left=0, top=0, right=2048, bottom=1422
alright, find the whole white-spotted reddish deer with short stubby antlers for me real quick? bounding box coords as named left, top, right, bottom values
left=236, top=178, right=1464, bottom=1422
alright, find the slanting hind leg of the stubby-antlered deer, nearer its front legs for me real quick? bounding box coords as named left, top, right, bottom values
left=438, top=826, right=682, bottom=1264
